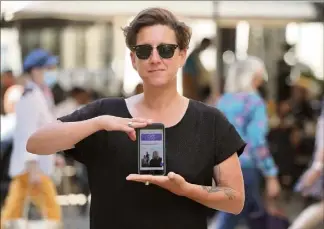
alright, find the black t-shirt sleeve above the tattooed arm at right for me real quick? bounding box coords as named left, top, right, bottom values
left=215, top=111, right=246, bottom=165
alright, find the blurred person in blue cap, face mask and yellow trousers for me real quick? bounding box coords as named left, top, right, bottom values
left=1, top=49, right=61, bottom=228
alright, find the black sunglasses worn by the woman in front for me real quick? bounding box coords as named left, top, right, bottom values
left=132, top=44, right=179, bottom=60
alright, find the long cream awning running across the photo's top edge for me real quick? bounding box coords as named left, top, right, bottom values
left=2, top=1, right=317, bottom=21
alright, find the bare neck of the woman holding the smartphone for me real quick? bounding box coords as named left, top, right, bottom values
left=143, top=80, right=181, bottom=110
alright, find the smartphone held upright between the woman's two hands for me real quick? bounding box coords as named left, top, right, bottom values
left=136, top=123, right=166, bottom=176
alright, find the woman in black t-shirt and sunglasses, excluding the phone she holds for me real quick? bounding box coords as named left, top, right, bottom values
left=27, top=8, right=245, bottom=229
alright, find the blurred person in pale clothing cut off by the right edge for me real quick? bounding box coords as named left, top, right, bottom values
left=289, top=102, right=324, bottom=229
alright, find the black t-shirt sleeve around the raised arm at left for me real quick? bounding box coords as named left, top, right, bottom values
left=58, top=100, right=101, bottom=165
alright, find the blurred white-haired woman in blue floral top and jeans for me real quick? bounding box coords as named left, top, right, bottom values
left=216, top=57, right=280, bottom=229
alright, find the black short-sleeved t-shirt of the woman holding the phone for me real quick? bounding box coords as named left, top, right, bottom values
left=59, top=98, right=245, bottom=229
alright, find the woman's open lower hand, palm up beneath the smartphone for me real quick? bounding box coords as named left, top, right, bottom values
left=126, top=172, right=190, bottom=196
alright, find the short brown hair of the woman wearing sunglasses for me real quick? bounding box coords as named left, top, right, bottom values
left=123, top=8, right=191, bottom=50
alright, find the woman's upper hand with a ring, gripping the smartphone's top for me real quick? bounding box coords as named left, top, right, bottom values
left=97, top=115, right=152, bottom=141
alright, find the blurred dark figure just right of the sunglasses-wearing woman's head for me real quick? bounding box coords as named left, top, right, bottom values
left=182, top=38, right=212, bottom=101
